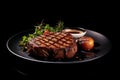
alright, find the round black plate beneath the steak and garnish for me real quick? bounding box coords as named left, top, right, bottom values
left=6, top=30, right=111, bottom=64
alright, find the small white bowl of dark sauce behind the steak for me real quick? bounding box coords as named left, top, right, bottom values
left=63, top=27, right=87, bottom=38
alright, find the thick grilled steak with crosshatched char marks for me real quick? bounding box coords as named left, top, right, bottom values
left=27, top=32, right=77, bottom=59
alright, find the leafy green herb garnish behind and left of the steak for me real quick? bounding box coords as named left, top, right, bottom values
left=19, top=21, right=64, bottom=49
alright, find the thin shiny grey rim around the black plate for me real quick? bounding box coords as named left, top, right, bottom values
left=6, top=27, right=111, bottom=64
